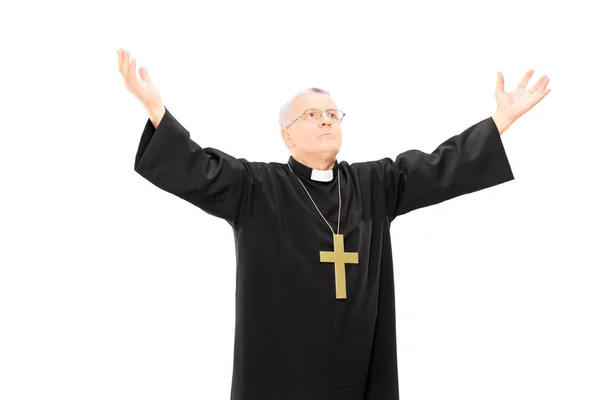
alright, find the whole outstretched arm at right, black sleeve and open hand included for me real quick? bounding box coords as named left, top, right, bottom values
left=373, top=69, right=550, bottom=221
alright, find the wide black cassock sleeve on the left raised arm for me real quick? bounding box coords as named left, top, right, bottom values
left=134, top=105, right=254, bottom=226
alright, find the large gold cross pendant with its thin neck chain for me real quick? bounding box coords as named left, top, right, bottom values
left=287, top=162, right=358, bottom=299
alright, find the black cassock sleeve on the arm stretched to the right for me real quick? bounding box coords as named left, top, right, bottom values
left=372, top=117, right=514, bottom=221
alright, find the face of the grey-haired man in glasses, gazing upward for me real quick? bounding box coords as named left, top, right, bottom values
left=281, top=92, right=342, bottom=156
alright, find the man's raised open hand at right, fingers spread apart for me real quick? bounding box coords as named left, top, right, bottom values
left=496, top=69, right=550, bottom=122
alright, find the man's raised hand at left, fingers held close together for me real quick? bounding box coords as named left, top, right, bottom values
left=117, top=49, right=165, bottom=128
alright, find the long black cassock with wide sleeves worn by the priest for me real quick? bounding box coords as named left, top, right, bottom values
left=134, top=109, right=514, bottom=400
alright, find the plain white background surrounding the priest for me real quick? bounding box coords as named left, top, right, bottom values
left=0, top=1, right=600, bottom=400
